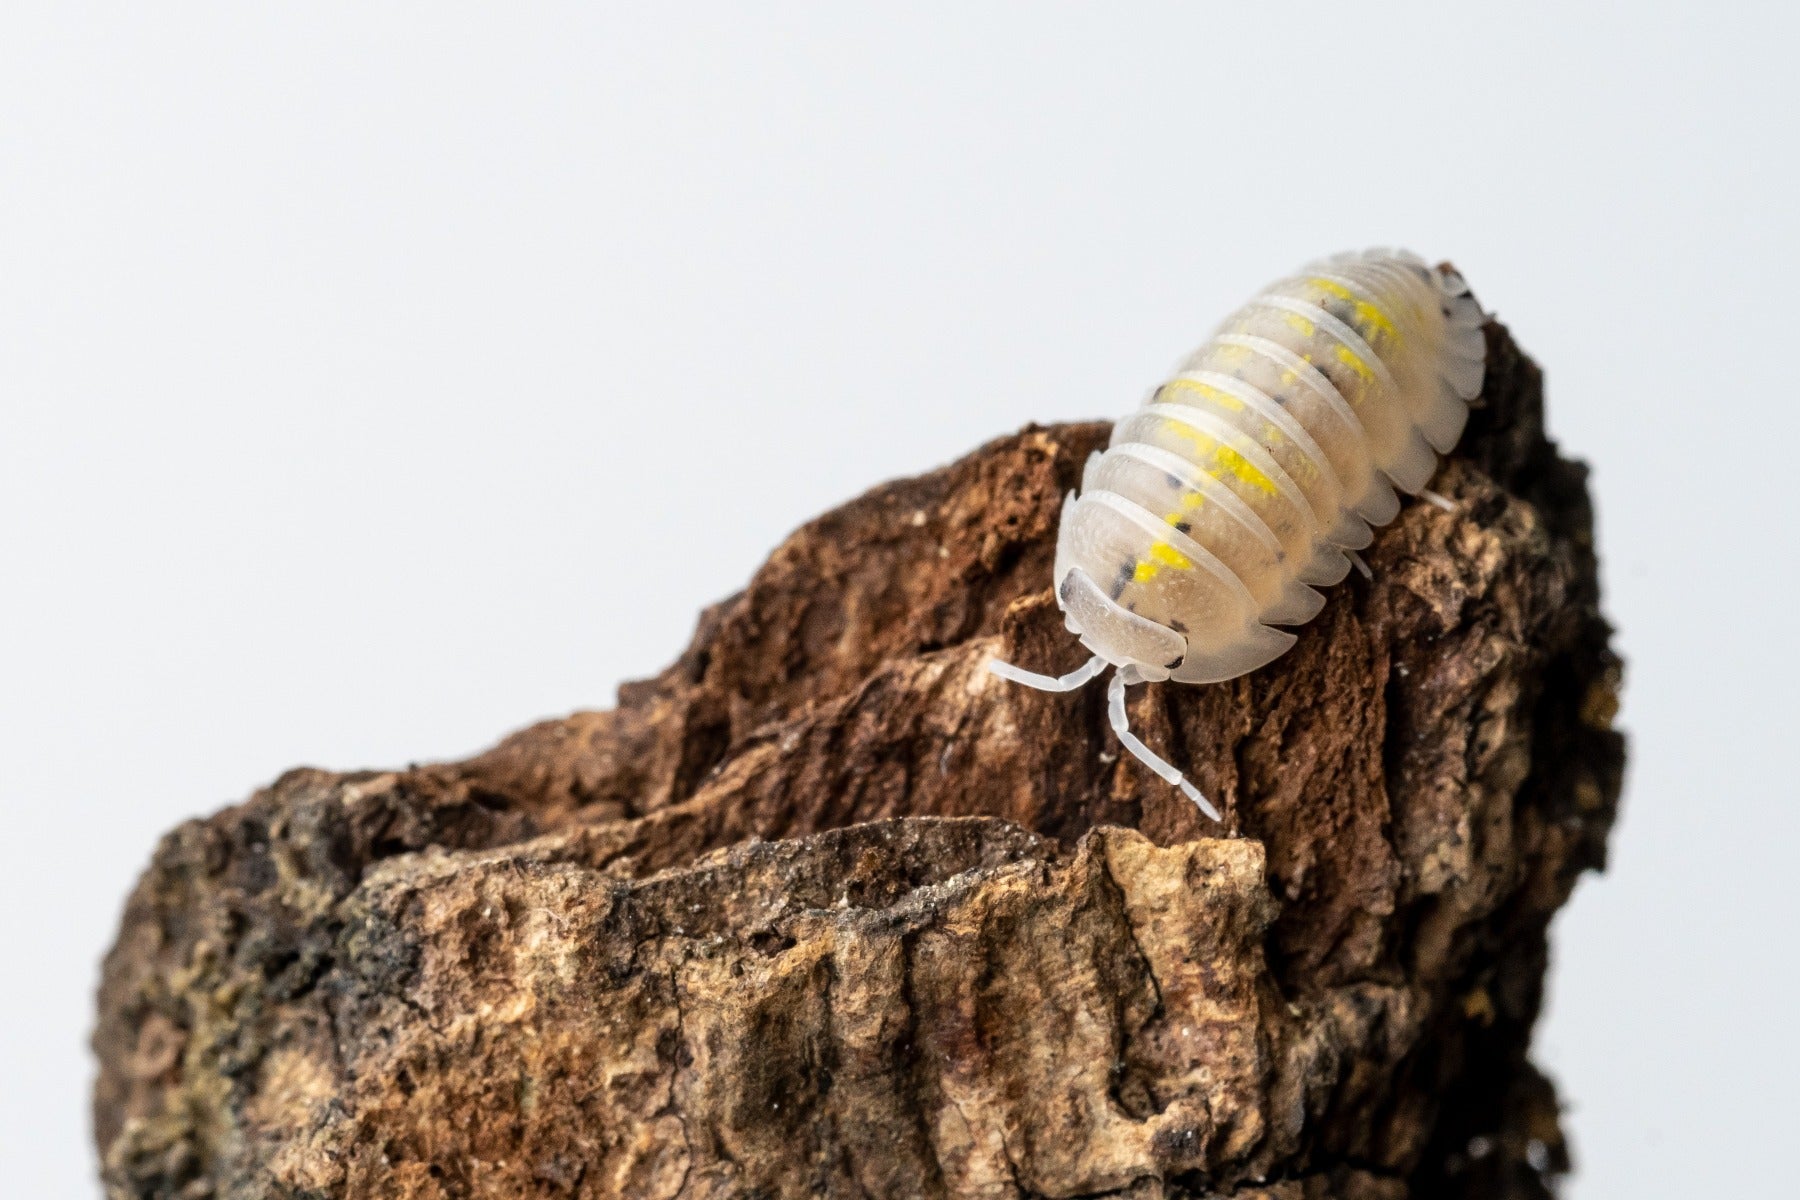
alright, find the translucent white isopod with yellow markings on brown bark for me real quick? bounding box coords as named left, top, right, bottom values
left=988, top=250, right=1487, bottom=820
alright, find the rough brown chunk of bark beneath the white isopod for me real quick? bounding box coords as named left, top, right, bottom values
left=95, top=314, right=1624, bottom=1200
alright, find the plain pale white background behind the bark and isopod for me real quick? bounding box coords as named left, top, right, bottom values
left=0, top=0, right=1800, bottom=1200
